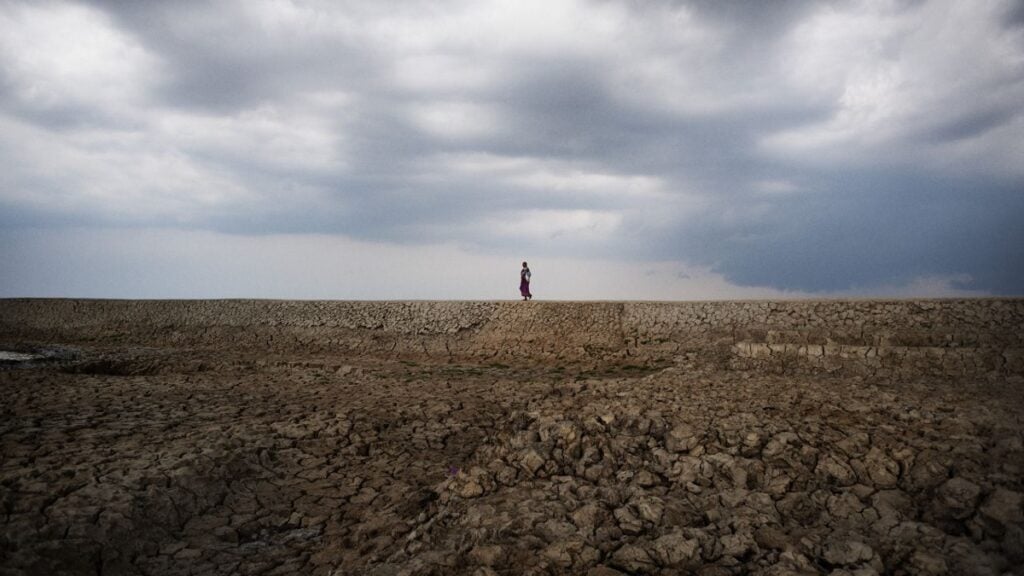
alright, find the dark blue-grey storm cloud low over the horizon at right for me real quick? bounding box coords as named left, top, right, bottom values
left=676, top=173, right=1024, bottom=293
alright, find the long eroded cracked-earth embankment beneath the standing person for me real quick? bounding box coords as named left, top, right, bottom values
left=0, top=299, right=1024, bottom=380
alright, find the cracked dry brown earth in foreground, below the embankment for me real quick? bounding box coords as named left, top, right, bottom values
left=0, top=349, right=1024, bottom=576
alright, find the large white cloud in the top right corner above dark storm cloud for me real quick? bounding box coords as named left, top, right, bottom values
left=761, top=1, right=1024, bottom=175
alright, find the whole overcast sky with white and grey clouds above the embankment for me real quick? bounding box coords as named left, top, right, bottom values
left=0, top=0, right=1024, bottom=299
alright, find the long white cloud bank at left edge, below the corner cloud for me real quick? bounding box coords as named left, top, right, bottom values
left=0, top=87, right=347, bottom=224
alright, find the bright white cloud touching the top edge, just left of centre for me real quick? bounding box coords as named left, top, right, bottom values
left=378, top=0, right=629, bottom=97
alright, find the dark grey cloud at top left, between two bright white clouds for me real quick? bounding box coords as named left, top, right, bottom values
left=79, top=0, right=379, bottom=113
